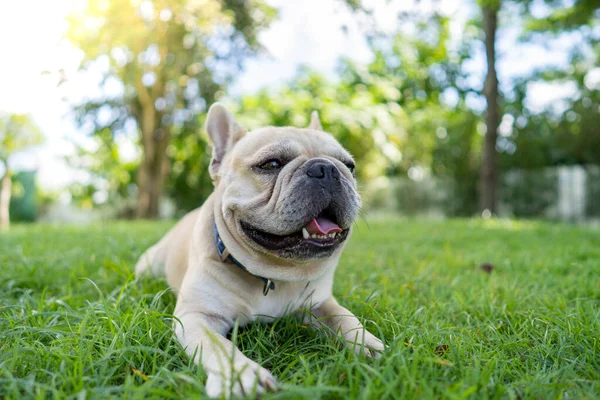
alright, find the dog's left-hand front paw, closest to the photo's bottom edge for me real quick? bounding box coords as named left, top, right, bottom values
left=206, top=360, right=277, bottom=399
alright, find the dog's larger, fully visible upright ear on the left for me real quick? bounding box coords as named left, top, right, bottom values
left=206, top=103, right=248, bottom=180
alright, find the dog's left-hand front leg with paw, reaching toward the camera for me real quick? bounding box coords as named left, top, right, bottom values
left=175, top=302, right=277, bottom=398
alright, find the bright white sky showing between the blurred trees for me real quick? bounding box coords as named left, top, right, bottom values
left=0, top=0, right=570, bottom=189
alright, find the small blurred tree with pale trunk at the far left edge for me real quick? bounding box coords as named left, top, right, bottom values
left=0, top=114, right=43, bottom=229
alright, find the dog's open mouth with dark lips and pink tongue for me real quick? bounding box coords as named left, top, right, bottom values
left=240, top=211, right=349, bottom=253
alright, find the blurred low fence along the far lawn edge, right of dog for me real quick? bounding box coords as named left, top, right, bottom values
left=367, top=165, right=600, bottom=222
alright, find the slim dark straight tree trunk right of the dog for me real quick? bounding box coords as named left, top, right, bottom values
left=479, top=1, right=500, bottom=213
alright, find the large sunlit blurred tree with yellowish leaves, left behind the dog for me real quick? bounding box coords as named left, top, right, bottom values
left=66, top=0, right=275, bottom=218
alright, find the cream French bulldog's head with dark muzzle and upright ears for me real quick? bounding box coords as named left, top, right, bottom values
left=206, top=103, right=360, bottom=278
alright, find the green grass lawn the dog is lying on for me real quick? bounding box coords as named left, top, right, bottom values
left=0, top=219, right=600, bottom=400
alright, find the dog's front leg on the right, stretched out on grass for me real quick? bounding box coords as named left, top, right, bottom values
left=311, top=297, right=385, bottom=357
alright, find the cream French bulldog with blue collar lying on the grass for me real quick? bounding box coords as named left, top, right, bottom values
left=136, top=103, right=384, bottom=397
